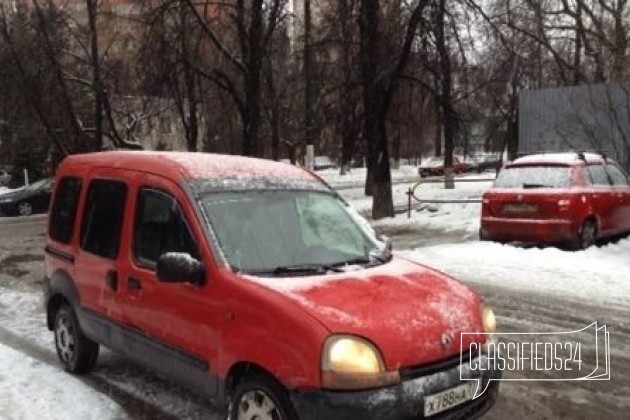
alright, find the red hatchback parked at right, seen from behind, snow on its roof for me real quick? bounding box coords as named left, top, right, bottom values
left=480, top=153, right=630, bottom=249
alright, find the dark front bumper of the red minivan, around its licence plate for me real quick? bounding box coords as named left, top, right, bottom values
left=291, top=357, right=501, bottom=420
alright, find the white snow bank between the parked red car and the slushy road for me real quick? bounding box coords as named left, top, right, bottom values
left=400, top=238, right=630, bottom=308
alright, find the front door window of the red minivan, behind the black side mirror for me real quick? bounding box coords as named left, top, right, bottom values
left=133, top=188, right=199, bottom=267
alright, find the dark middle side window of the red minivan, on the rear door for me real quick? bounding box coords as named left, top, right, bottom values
left=81, top=179, right=127, bottom=259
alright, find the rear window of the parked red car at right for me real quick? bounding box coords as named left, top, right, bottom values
left=494, top=165, right=571, bottom=188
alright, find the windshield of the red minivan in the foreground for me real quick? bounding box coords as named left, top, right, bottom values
left=200, top=191, right=383, bottom=273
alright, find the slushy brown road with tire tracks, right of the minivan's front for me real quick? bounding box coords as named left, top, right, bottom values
left=474, top=284, right=630, bottom=420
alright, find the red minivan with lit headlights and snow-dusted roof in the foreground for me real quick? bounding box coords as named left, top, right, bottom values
left=44, top=152, right=501, bottom=420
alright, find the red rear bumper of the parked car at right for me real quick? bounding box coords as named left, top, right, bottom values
left=481, top=216, right=578, bottom=244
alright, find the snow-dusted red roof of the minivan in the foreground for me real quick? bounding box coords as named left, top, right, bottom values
left=64, top=151, right=317, bottom=182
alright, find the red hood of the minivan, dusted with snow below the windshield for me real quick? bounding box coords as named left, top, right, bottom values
left=247, top=258, right=483, bottom=369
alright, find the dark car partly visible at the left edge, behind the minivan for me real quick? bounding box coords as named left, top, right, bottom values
left=0, top=178, right=53, bottom=216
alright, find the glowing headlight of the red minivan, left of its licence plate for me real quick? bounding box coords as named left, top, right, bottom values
left=321, top=335, right=400, bottom=389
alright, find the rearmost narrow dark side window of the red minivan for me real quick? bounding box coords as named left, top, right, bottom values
left=48, top=177, right=81, bottom=244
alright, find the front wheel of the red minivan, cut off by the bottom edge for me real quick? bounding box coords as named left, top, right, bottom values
left=227, top=373, right=298, bottom=420
